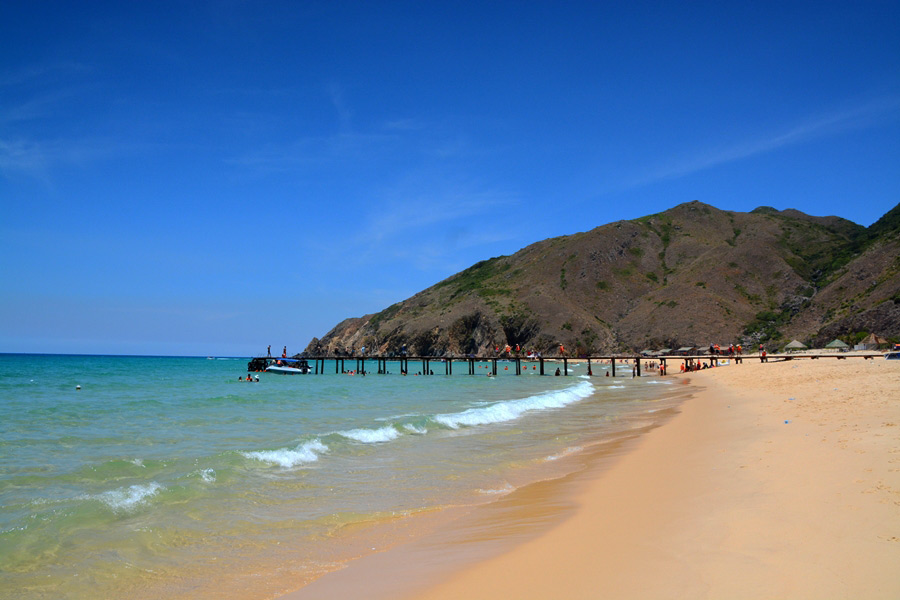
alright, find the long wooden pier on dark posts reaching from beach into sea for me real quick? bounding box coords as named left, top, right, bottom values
left=256, top=353, right=882, bottom=377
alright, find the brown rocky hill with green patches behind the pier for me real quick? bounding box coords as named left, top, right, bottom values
left=306, top=202, right=900, bottom=356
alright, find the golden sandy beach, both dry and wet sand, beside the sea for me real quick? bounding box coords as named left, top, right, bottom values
left=288, top=357, right=900, bottom=600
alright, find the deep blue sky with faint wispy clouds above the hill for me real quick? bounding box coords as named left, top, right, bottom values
left=0, top=0, right=900, bottom=356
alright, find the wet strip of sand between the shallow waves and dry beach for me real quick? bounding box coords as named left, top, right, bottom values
left=276, top=386, right=686, bottom=600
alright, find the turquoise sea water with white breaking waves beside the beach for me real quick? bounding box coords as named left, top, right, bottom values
left=0, top=355, right=679, bottom=598
